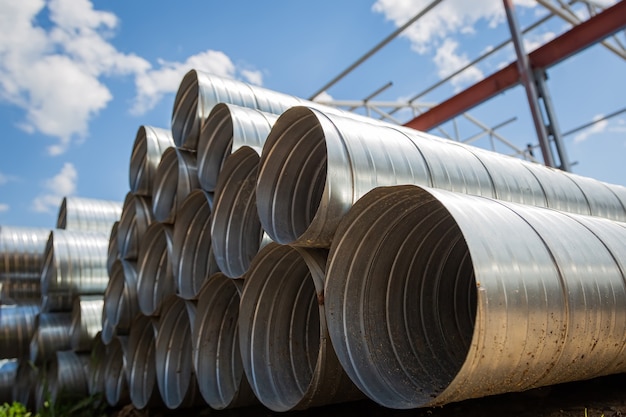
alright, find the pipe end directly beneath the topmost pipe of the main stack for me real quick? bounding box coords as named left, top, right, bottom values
left=152, top=148, right=200, bottom=223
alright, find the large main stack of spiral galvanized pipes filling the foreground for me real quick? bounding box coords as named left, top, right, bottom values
left=86, top=70, right=626, bottom=411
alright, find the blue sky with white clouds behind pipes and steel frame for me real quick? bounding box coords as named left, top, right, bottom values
left=0, top=0, right=626, bottom=228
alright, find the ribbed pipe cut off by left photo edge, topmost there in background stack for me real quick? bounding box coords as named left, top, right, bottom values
left=0, top=226, right=50, bottom=303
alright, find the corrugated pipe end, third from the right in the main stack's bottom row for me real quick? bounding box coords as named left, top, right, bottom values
left=192, top=272, right=258, bottom=410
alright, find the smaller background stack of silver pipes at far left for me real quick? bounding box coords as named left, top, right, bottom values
left=0, top=197, right=121, bottom=410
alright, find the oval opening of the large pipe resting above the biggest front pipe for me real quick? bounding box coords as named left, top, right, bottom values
left=256, top=108, right=327, bottom=244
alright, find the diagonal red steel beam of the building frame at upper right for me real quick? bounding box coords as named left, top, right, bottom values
left=405, top=0, right=626, bottom=131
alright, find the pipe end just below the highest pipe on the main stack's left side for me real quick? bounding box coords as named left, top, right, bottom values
left=117, top=193, right=154, bottom=260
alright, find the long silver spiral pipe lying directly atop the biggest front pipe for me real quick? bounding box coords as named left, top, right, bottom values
left=257, top=107, right=626, bottom=247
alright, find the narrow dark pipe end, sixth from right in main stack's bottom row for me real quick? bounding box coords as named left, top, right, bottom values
left=104, top=336, right=130, bottom=407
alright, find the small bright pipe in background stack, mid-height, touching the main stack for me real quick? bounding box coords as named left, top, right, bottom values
left=70, top=295, right=104, bottom=352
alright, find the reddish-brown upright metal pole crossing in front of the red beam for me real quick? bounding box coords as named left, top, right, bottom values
left=502, top=0, right=555, bottom=167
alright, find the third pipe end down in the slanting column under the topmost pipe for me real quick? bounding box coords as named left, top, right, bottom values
left=137, top=223, right=176, bottom=316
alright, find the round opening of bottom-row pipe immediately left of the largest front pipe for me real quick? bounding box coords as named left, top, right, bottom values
left=239, top=244, right=321, bottom=411
